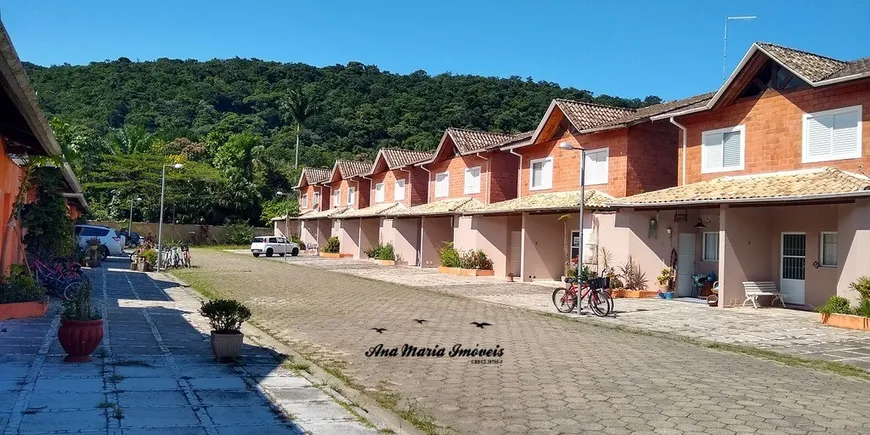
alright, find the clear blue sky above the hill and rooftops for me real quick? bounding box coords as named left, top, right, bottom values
left=0, top=0, right=870, bottom=99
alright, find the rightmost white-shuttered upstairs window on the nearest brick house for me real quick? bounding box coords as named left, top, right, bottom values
left=803, top=106, right=861, bottom=163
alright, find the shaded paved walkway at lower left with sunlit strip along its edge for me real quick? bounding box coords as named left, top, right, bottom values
left=0, top=263, right=377, bottom=435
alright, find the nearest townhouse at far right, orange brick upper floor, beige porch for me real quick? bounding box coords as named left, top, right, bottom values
left=614, top=43, right=870, bottom=309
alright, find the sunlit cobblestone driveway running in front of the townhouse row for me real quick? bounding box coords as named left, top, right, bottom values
left=182, top=250, right=870, bottom=434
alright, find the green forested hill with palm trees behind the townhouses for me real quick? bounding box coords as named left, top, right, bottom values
left=26, top=58, right=659, bottom=223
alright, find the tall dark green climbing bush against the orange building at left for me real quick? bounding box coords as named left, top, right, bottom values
left=21, top=168, right=76, bottom=259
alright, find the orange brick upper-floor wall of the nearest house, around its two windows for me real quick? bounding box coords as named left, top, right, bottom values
left=678, top=79, right=870, bottom=183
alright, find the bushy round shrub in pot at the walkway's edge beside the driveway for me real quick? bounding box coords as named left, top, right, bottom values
left=199, top=299, right=251, bottom=361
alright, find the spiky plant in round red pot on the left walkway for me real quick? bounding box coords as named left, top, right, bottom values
left=57, top=282, right=103, bottom=362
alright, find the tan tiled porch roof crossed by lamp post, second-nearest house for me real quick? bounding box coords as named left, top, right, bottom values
left=467, top=189, right=614, bottom=214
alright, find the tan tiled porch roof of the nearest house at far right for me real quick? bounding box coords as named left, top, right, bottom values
left=613, top=168, right=870, bottom=206
